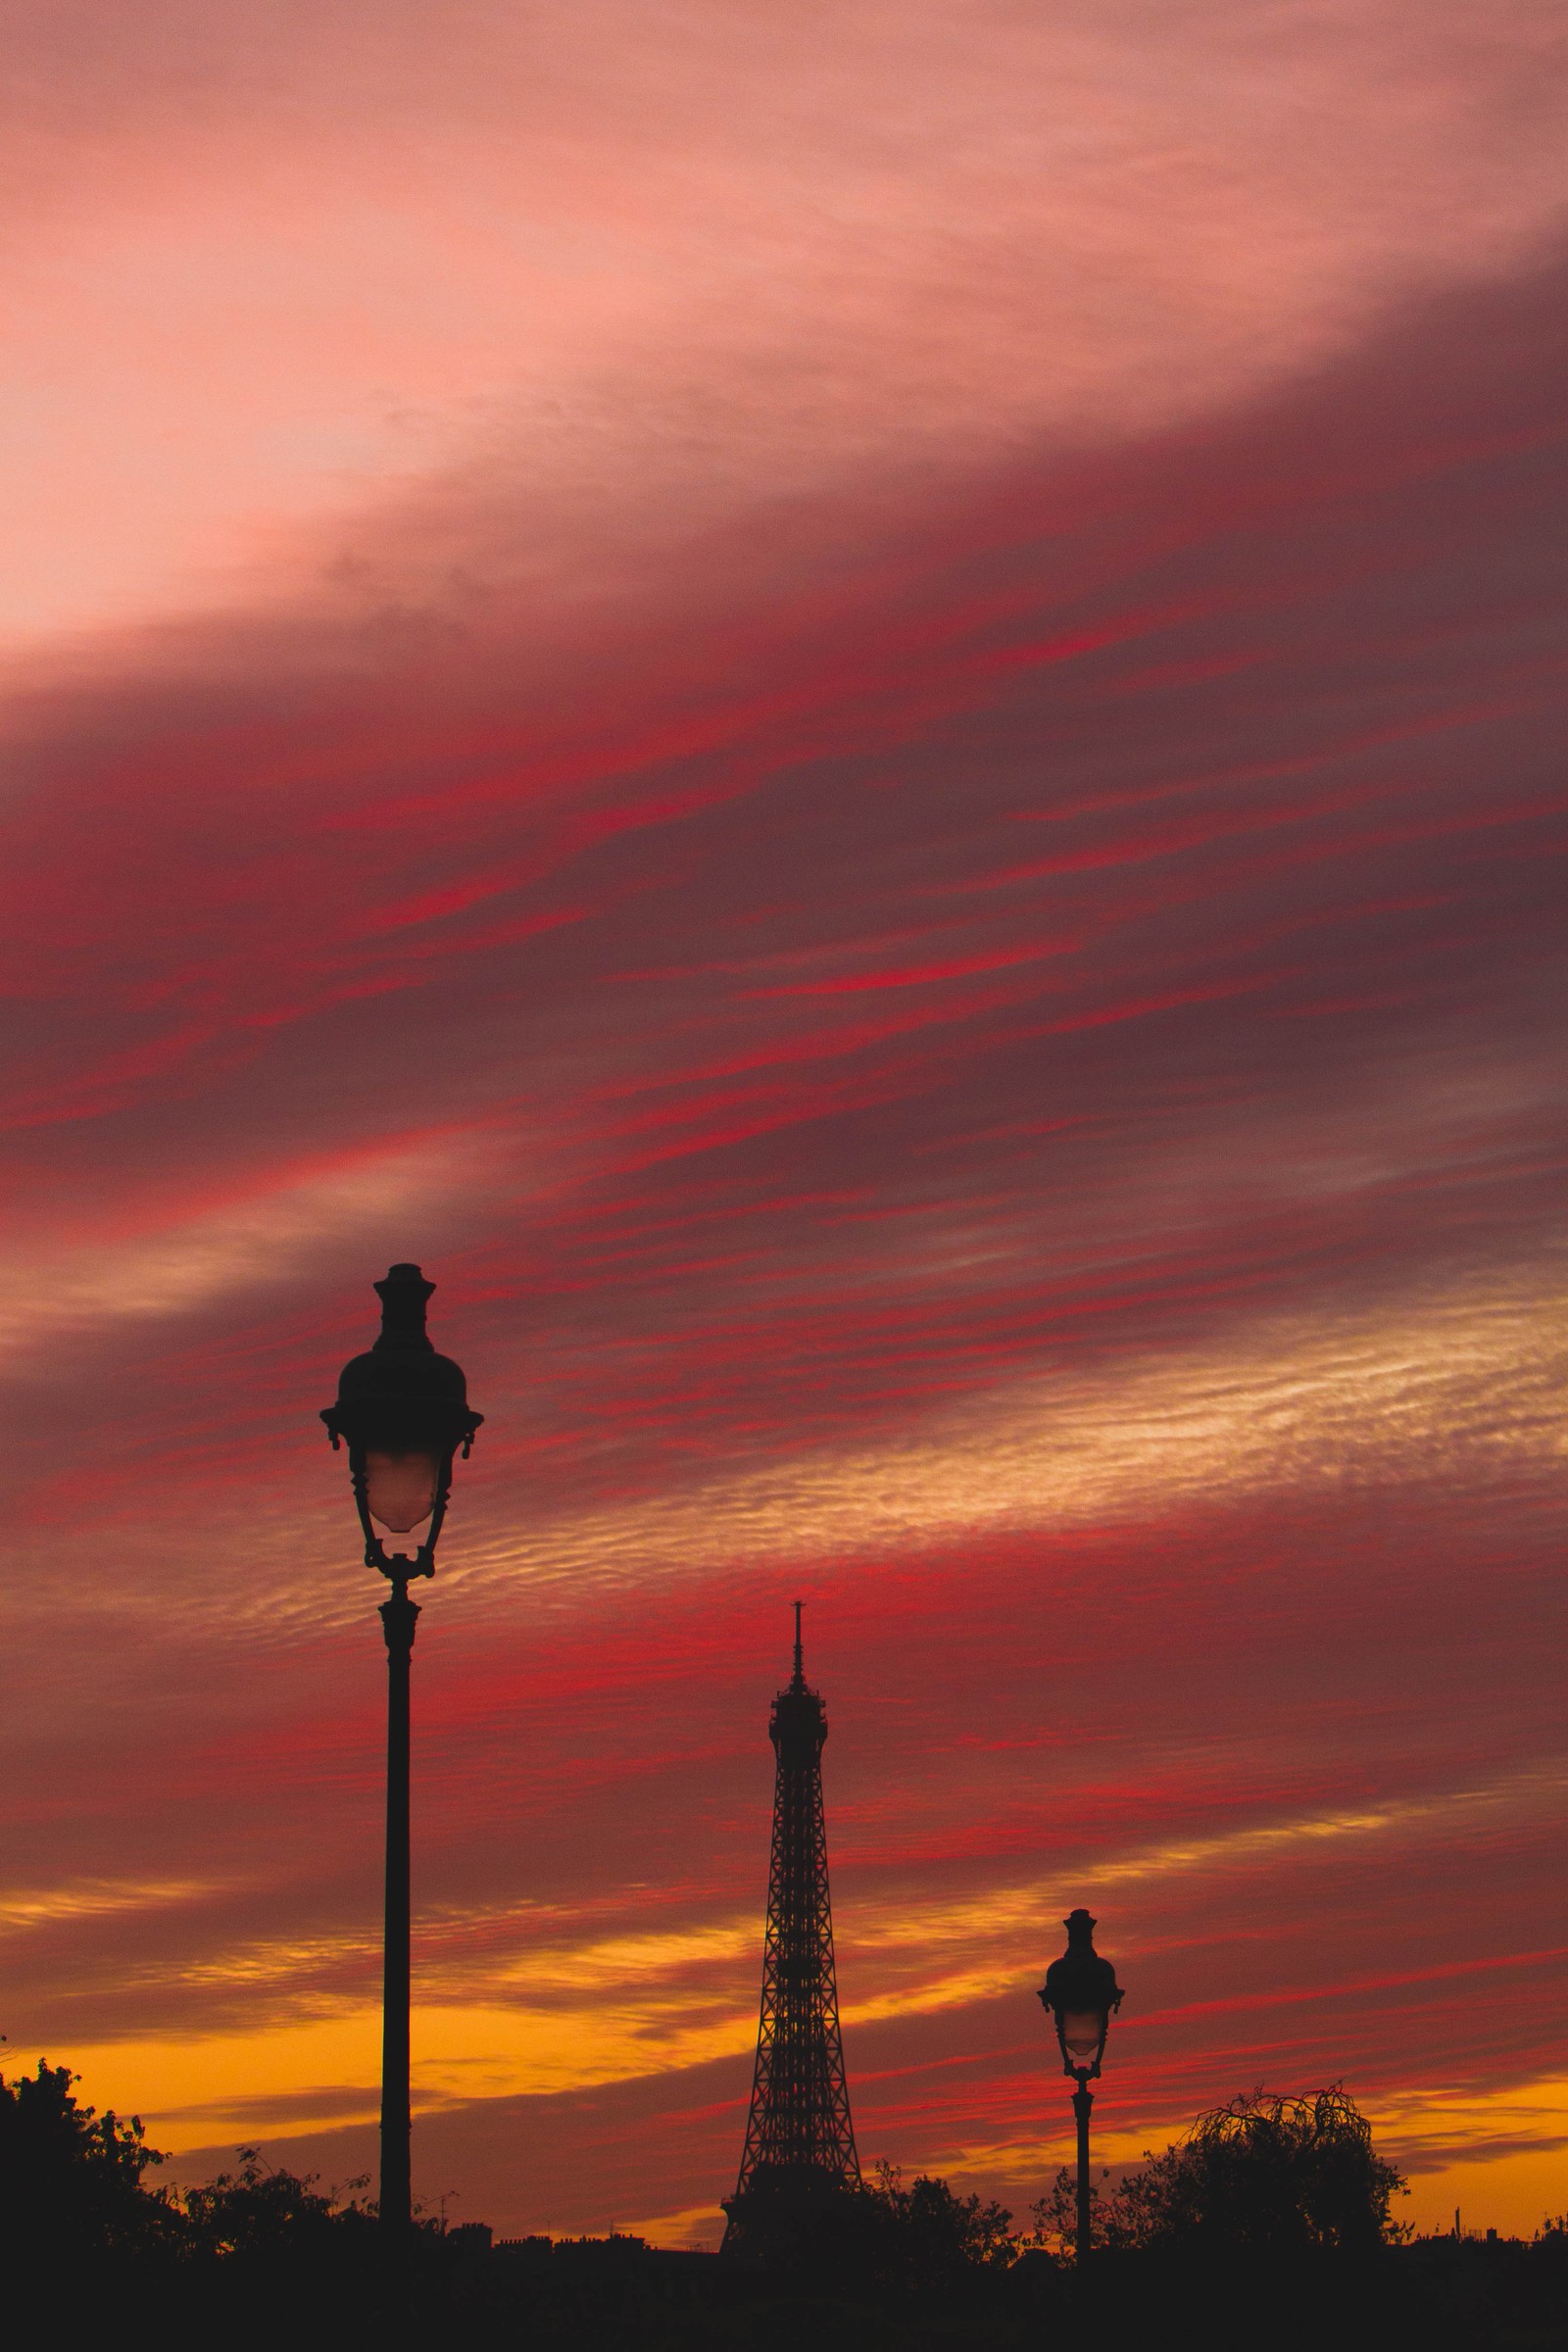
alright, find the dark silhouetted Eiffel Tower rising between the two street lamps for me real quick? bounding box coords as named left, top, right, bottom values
left=724, top=1601, right=860, bottom=2241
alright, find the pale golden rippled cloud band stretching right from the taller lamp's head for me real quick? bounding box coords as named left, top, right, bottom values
left=459, top=1275, right=1568, bottom=1583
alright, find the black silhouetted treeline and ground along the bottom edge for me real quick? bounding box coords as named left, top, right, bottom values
left=0, top=2060, right=1568, bottom=2352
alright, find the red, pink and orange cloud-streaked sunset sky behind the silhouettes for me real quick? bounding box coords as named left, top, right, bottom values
left=0, top=0, right=1568, bottom=2244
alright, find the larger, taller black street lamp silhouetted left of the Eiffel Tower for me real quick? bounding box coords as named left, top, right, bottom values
left=322, top=1265, right=484, bottom=2241
